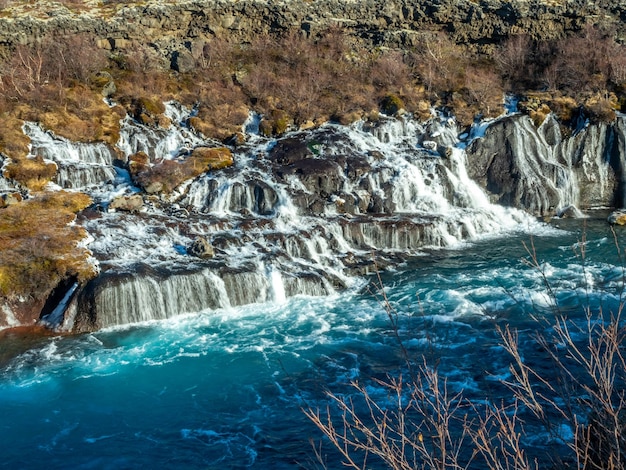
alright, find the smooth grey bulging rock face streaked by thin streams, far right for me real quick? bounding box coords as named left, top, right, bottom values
left=468, top=115, right=626, bottom=215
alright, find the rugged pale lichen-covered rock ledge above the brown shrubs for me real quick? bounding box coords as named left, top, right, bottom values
left=0, top=0, right=626, bottom=52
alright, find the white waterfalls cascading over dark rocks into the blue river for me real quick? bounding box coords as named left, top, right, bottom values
left=19, top=103, right=620, bottom=329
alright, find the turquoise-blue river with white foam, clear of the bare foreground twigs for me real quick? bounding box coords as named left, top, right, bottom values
left=0, top=215, right=626, bottom=469
